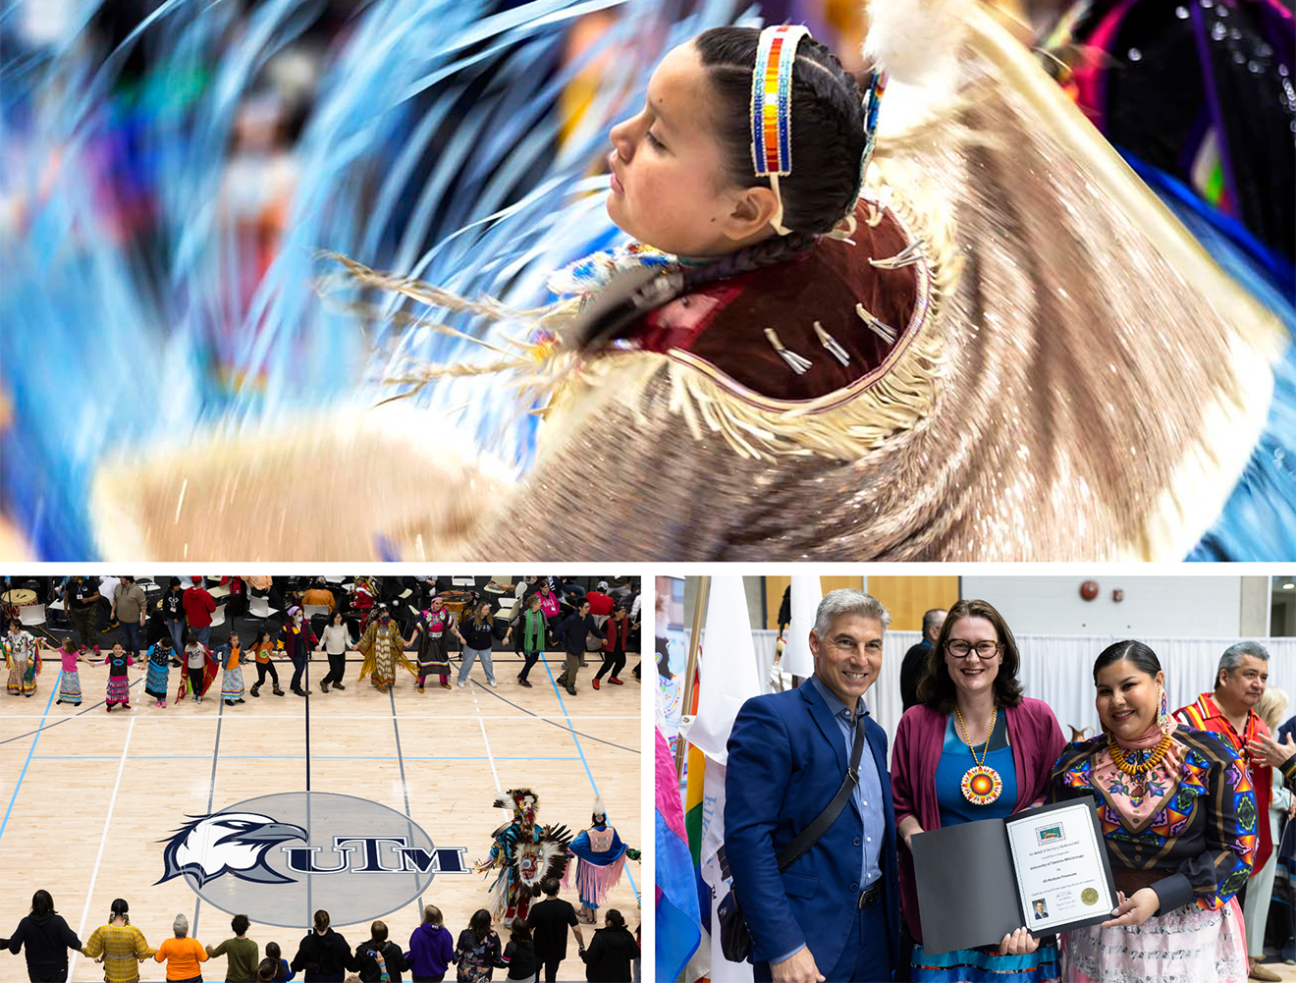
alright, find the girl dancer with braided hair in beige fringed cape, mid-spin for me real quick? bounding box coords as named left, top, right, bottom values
left=86, top=0, right=1296, bottom=562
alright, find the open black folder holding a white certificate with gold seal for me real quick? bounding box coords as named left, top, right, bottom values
left=912, top=798, right=1116, bottom=954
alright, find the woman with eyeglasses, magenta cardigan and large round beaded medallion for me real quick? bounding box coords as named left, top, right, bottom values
left=892, top=600, right=1067, bottom=983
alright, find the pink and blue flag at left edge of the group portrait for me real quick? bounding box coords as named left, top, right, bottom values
left=656, top=725, right=702, bottom=983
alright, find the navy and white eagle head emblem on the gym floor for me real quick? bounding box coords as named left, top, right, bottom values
left=157, top=812, right=307, bottom=887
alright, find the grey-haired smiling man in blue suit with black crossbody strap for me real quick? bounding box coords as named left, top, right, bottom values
left=724, top=590, right=899, bottom=983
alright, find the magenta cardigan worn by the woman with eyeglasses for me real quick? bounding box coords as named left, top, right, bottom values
left=892, top=698, right=1067, bottom=944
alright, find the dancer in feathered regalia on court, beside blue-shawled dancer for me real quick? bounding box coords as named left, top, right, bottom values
left=473, top=788, right=572, bottom=922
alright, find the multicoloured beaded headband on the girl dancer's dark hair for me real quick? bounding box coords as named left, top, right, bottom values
left=752, top=23, right=810, bottom=236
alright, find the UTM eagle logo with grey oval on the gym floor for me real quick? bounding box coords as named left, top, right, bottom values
left=157, top=792, right=470, bottom=929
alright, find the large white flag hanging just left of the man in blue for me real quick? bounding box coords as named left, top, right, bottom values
left=682, top=577, right=762, bottom=983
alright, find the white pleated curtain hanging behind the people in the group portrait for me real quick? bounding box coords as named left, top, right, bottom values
left=704, top=629, right=1296, bottom=767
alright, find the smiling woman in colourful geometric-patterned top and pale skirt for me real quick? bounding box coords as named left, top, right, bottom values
left=1050, top=641, right=1260, bottom=983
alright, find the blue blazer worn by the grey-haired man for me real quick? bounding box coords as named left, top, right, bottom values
left=724, top=680, right=899, bottom=977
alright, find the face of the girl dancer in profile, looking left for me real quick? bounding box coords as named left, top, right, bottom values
left=608, top=41, right=775, bottom=257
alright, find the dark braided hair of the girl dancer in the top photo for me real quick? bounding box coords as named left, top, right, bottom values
left=575, top=27, right=867, bottom=350
